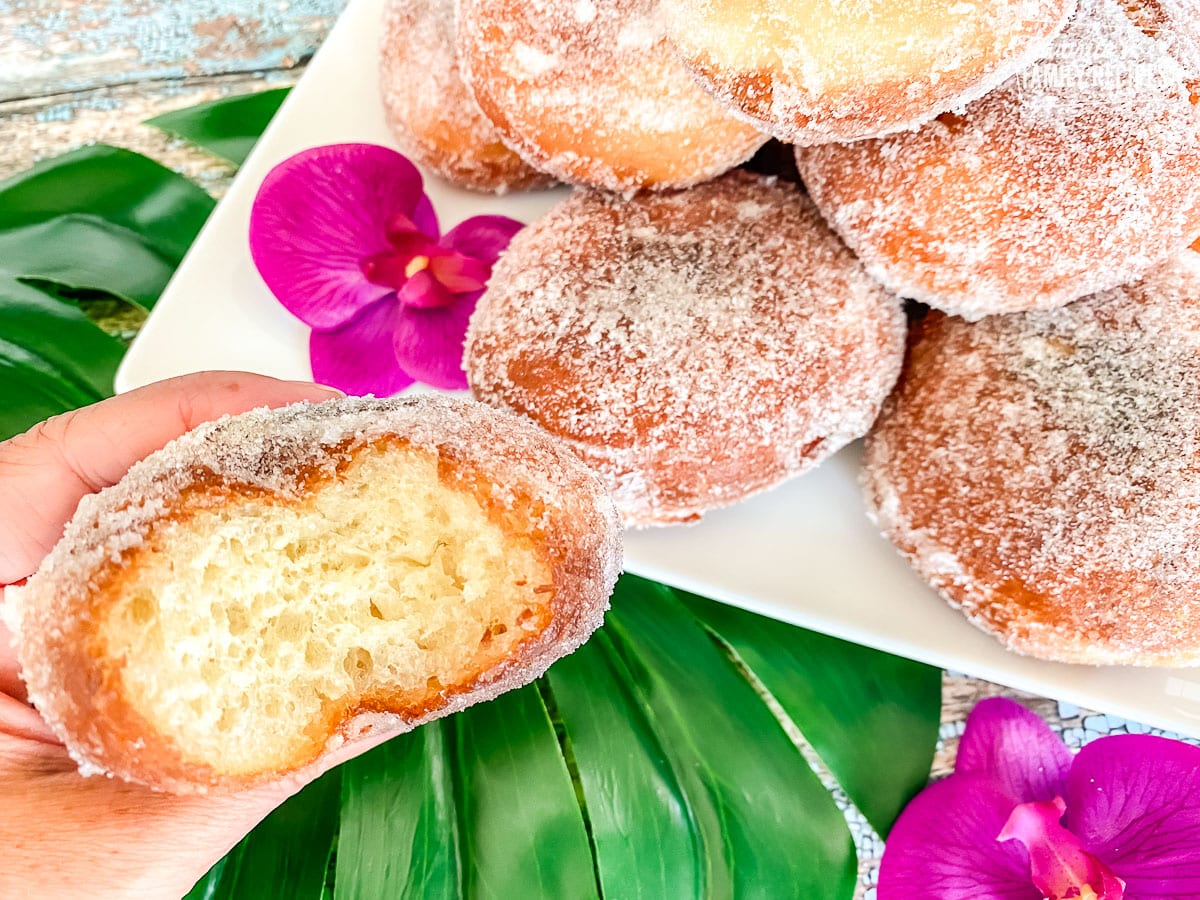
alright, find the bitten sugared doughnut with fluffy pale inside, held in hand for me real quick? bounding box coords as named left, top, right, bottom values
left=6, top=396, right=620, bottom=793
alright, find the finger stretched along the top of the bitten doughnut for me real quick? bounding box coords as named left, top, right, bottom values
left=0, top=372, right=340, bottom=588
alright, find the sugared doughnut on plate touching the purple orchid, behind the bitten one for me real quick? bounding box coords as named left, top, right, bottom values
left=466, top=173, right=905, bottom=524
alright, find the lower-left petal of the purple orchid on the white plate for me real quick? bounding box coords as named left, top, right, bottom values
left=308, top=296, right=413, bottom=397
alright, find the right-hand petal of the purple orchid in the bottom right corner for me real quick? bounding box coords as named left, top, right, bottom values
left=1067, top=734, right=1200, bottom=900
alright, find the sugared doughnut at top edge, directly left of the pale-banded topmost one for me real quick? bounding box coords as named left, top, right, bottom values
left=458, top=0, right=767, bottom=193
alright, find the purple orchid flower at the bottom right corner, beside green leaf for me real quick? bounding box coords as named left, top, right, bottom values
left=878, top=698, right=1200, bottom=900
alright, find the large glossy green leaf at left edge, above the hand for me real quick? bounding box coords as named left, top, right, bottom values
left=0, top=145, right=212, bottom=439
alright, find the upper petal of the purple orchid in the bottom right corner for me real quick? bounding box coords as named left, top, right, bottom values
left=954, top=697, right=1070, bottom=806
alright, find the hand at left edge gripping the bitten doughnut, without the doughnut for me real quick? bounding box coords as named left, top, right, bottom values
left=0, top=373, right=345, bottom=898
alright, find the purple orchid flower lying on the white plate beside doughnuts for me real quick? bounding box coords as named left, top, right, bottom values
left=250, top=144, right=522, bottom=396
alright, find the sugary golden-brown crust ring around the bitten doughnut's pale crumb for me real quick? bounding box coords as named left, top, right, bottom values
left=13, top=397, right=619, bottom=792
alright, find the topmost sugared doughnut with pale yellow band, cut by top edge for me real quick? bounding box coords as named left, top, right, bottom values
left=662, top=0, right=1075, bottom=146
